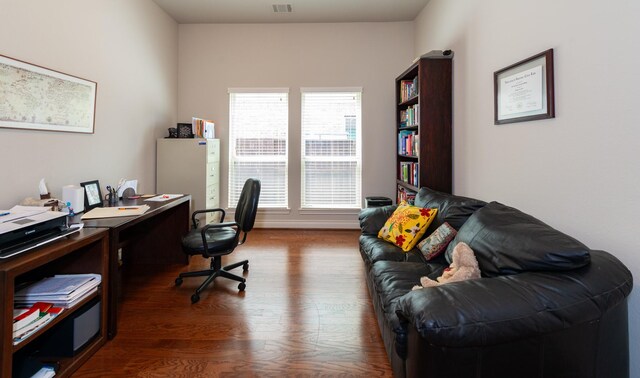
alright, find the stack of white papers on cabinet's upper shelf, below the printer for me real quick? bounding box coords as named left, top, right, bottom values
left=14, top=274, right=102, bottom=308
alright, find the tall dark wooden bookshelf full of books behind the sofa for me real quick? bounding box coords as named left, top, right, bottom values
left=396, top=51, right=453, bottom=203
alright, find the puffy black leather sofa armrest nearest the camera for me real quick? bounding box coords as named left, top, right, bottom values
left=396, top=251, right=633, bottom=347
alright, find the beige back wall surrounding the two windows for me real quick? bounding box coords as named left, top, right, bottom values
left=178, top=22, right=414, bottom=228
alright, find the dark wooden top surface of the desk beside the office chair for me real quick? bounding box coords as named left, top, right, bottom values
left=70, top=194, right=191, bottom=228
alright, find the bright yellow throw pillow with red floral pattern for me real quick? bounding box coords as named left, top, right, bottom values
left=378, top=201, right=438, bottom=252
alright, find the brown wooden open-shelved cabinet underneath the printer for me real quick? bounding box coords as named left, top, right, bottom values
left=0, top=228, right=109, bottom=377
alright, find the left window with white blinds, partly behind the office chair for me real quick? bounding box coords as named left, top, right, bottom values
left=229, top=89, right=289, bottom=208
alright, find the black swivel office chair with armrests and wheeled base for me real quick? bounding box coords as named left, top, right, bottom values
left=176, top=179, right=260, bottom=303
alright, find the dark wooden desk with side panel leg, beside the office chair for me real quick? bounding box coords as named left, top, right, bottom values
left=73, top=195, right=191, bottom=339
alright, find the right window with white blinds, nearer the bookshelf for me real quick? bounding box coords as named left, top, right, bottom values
left=301, top=88, right=362, bottom=208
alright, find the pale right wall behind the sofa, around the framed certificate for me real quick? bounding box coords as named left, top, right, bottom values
left=415, top=0, right=640, bottom=377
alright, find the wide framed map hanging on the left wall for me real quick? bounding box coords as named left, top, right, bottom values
left=0, top=55, right=98, bottom=134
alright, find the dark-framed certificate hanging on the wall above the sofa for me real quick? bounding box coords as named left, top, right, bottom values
left=493, top=49, right=556, bottom=125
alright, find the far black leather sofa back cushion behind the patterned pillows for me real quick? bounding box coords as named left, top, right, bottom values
left=415, top=187, right=487, bottom=235
